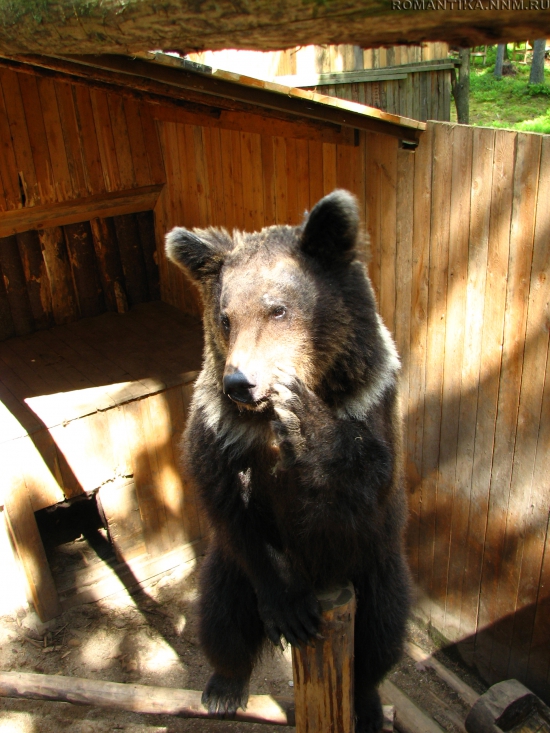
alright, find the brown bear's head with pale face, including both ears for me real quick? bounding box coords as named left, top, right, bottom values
left=166, top=190, right=388, bottom=411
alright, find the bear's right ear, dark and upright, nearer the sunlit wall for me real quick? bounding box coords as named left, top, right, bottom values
left=301, top=189, right=359, bottom=267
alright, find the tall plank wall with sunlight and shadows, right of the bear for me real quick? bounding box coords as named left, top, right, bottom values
left=365, top=123, right=550, bottom=701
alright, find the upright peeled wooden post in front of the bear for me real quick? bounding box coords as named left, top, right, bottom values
left=292, top=584, right=355, bottom=733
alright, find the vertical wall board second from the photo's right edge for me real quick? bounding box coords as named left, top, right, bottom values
left=491, top=133, right=542, bottom=677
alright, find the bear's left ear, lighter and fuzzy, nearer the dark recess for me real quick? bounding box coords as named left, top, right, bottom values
left=166, top=227, right=233, bottom=282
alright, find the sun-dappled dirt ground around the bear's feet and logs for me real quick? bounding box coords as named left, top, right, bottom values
left=0, top=556, right=484, bottom=733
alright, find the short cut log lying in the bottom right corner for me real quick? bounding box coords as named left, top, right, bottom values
left=466, top=680, right=550, bottom=733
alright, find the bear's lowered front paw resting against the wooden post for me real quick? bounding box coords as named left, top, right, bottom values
left=258, top=590, right=321, bottom=647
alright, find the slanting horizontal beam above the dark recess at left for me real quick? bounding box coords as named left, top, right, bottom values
left=0, top=184, right=164, bottom=237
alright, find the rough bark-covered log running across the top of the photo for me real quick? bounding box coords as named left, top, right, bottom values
left=0, top=0, right=550, bottom=54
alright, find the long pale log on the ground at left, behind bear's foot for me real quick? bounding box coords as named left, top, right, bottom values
left=0, top=672, right=294, bottom=725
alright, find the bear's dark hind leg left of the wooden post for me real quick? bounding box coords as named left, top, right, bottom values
left=199, top=546, right=265, bottom=718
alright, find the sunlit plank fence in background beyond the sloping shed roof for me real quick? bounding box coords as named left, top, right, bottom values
left=189, top=43, right=455, bottom=122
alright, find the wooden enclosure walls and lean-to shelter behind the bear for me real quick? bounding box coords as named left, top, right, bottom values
left=0, top=50, right=550, bottom=700
